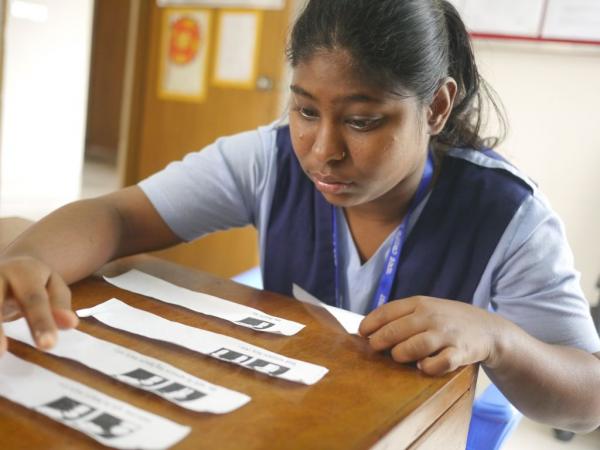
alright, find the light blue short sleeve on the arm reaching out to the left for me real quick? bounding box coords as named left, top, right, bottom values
left=139, top=127, right=275, bottom=241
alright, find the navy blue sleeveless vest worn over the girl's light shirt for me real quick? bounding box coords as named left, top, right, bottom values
left=264, top=127, right=532, bottom=305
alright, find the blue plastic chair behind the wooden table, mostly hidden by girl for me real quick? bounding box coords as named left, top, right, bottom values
left=232, top=267, right=523, bottom=450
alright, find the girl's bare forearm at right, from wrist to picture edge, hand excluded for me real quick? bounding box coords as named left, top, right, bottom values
left=484, top=323, right=600, bottom=432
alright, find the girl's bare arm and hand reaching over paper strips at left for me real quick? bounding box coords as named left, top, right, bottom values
left=0, top=186, right=179, bottom=354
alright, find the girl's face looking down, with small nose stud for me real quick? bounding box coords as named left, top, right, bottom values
left=290, top=50, right=429, bottom=214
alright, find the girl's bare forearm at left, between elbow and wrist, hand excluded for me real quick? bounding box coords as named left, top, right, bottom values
left=0, top=199, right=123, bottom=284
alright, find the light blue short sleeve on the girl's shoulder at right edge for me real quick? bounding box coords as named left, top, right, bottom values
left=478, top=195, right=600, bottom=353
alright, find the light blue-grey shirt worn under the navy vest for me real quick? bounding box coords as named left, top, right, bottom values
left=139, top=124, right=600, bottom=352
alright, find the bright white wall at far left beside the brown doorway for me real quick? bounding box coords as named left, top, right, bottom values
left=0, top=0, right=94, bottom=219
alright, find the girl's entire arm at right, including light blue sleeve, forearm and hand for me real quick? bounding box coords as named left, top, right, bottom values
left=361, top=198, right=600, bottom=431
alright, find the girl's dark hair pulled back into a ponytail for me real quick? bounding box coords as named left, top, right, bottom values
left=287, top=0, right=506, bottom=149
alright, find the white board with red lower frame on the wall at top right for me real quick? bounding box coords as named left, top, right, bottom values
left=449, top=0, right=600, bottom=45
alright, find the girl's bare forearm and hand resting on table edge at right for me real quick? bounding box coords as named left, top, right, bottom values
left=360, top=297, right=600, bottom=432
